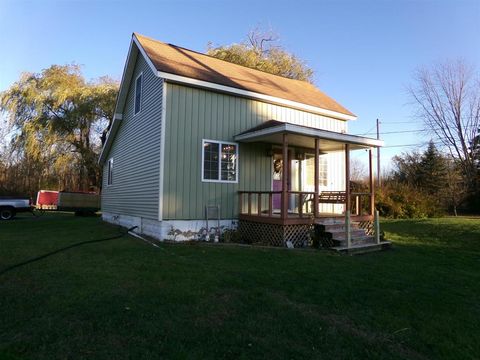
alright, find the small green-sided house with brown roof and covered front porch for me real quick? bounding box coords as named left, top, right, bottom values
left=99, top=33, right=383, bottom=246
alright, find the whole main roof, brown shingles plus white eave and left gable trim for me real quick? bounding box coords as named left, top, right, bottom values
left=98, top=33, right=356, bottom=164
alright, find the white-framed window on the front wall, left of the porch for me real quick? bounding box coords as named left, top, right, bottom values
left=202, top=140, right=238, bottom=182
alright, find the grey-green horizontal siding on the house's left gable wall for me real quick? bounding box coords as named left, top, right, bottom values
left=102, top=56, right=163, bottom=220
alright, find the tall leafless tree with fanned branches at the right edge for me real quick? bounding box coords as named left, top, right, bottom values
left=408, top=60, right=480, bottom=192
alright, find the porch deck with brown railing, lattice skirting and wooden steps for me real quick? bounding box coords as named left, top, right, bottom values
left=239, top=191, right=385, bottom=253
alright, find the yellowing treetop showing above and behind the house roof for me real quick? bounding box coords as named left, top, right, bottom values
left=207, top=29, right=313, bottom=83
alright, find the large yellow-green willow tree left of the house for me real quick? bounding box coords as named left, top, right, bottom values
left=0, top=65, right=118, bottom=190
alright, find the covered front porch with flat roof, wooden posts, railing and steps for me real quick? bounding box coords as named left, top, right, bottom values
left=235, top=120, right=390, bottom=249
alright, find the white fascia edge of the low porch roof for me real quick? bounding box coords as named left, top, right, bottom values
left=234, top=123, right=384, bottom=147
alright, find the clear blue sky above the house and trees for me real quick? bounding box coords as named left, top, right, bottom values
left=0, top=0, right=480, bottom=169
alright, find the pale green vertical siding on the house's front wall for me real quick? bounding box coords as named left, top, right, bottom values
left=163, top=83, right=346, bottom=220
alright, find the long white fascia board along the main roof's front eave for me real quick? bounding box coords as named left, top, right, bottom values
left=157, top=71, right=357, bottom=121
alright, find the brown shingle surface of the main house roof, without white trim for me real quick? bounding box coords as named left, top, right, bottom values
left=134, top=33, right=355, bottom=116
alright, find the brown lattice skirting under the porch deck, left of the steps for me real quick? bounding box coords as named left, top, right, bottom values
left=238, top=220, right=313, bottom=247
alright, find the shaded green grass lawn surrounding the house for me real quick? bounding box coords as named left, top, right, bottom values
left=0, top=214, right=480, bottom=359
